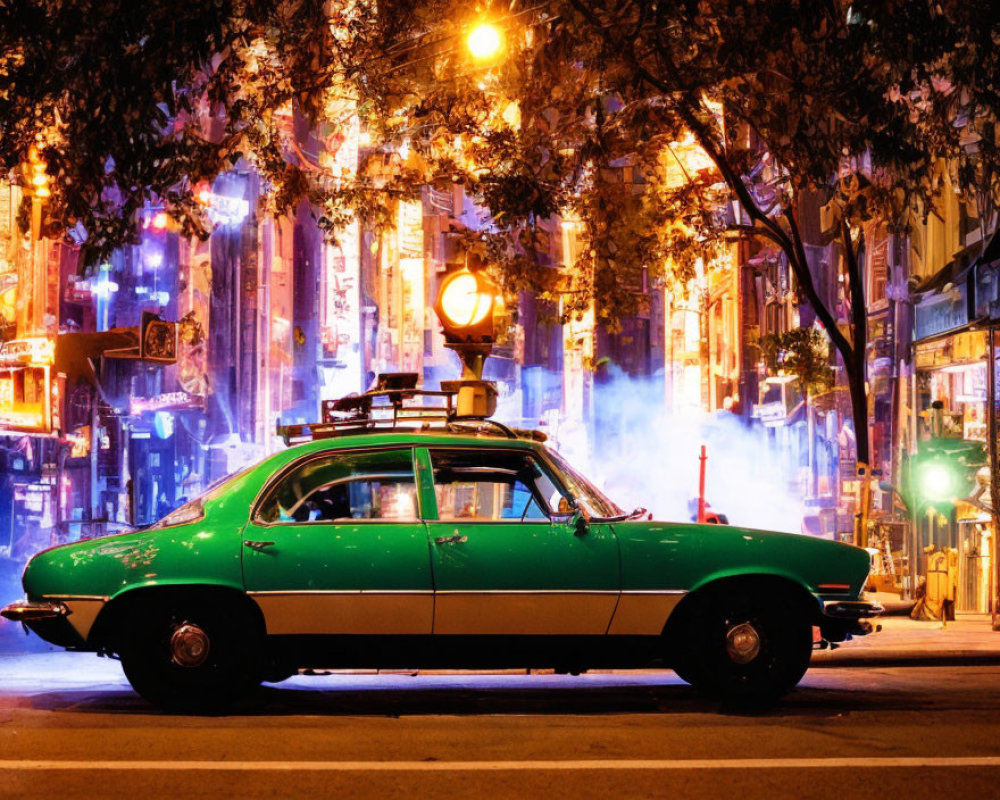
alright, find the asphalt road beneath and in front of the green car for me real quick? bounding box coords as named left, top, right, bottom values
left=0, top=653, right=1000, bottom=800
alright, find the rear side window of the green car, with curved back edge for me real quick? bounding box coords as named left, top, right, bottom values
left=256, top=449, right=417, bottom=524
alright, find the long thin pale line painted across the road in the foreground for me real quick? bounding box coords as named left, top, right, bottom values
left=0, top=756, right=1000, bottom=773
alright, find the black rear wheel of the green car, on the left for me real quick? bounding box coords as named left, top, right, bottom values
left=119, top=596, right=263, bottom=714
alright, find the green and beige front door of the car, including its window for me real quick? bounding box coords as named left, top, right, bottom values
left=418, top=446, right=620, bottom=635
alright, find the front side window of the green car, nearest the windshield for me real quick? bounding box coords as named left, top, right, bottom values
left=430, top=448, right=560, bottom=522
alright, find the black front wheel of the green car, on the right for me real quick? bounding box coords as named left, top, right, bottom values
left=670, top=587, right=812, bottom=706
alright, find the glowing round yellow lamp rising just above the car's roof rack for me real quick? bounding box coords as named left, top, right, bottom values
left=434, top=267, right=503, bottom=417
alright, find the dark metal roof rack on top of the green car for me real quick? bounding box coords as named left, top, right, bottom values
left=277, top=373, right=547, bottom=445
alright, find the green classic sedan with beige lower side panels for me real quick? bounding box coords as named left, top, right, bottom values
left=0, top=384, right=880, bottom=711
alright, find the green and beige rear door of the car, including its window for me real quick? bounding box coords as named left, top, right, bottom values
left=243, top=448, right=434, bottom=634
